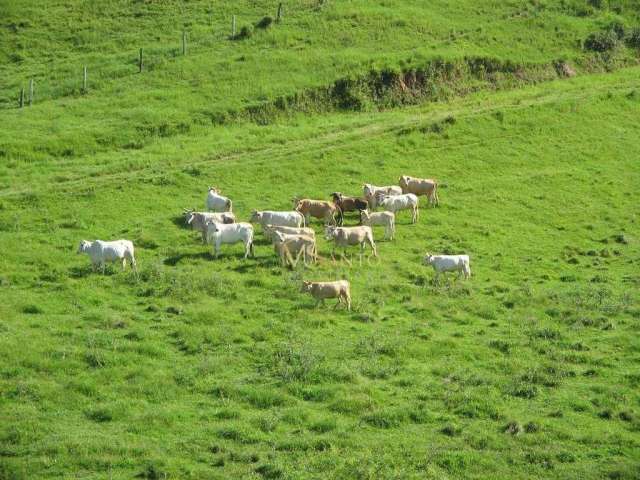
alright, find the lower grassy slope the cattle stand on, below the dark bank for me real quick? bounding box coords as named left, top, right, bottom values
left=0, top=69, right=640, bottom=479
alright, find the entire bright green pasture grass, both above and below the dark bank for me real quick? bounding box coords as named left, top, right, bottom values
left=0, top=1, right=640, bottom=479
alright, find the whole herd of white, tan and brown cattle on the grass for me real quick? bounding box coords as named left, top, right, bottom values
left=78, top=175, right=471, bottom=310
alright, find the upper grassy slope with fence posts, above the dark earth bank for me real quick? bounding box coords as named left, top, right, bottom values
left=0, top=0, right=640, bottom=163
